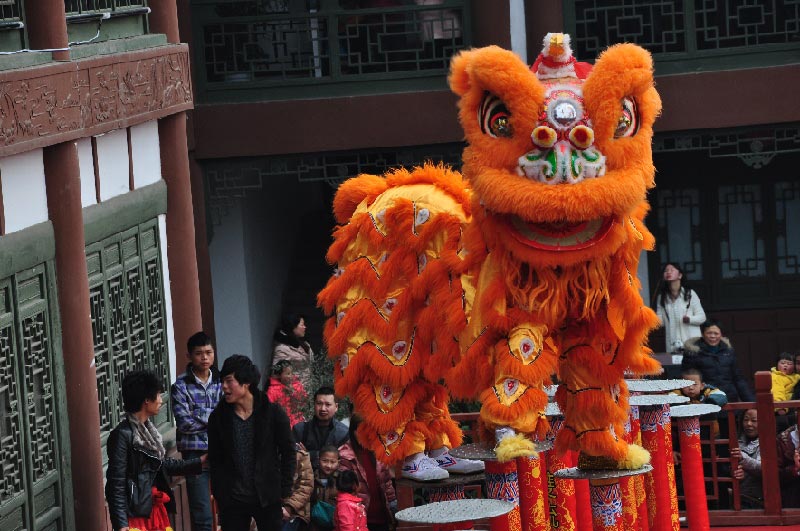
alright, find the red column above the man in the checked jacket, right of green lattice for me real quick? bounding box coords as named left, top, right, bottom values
left=154, top=114, right=203, bottom=352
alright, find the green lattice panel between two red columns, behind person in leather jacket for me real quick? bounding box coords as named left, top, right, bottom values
left=86, top=219, right=172, bottom=459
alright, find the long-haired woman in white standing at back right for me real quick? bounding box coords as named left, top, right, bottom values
left=655, top=262, right=706, bottom=352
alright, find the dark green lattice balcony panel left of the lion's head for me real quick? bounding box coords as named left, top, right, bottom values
left=192, top=0, right=471, bottom=100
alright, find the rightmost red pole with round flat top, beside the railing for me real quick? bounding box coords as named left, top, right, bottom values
left=672, top=404, right=720, bottom=531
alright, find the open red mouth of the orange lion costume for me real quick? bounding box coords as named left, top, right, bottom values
left=506, top=215, right=614, bottom=251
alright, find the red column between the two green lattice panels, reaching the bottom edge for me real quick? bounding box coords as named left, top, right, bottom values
left=44, top=141, right=106, bottom=530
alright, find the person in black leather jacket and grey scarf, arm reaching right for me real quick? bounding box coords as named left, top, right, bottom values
left=106, top=371, right=205, bottom=531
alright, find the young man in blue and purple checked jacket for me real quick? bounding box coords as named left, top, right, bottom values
left=171, top=332, right=222, bottom=531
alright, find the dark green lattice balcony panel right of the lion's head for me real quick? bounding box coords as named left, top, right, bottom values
left=564, top=0, right=800, bottom=74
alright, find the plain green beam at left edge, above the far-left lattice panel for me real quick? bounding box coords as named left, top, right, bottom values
left=0, top=221, right=56, bottom=278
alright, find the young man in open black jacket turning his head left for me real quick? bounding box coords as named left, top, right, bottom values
left=208, top=355, right=295, bottom=531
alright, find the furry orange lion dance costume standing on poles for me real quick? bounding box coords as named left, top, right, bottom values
left=319, top=34, right=661, bottom=477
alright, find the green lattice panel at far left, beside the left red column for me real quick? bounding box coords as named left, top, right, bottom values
left=0, top=262, right=73, bottom=531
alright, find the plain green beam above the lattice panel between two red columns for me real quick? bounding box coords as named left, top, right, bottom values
left=83, top=180, right=167, bottom=245
